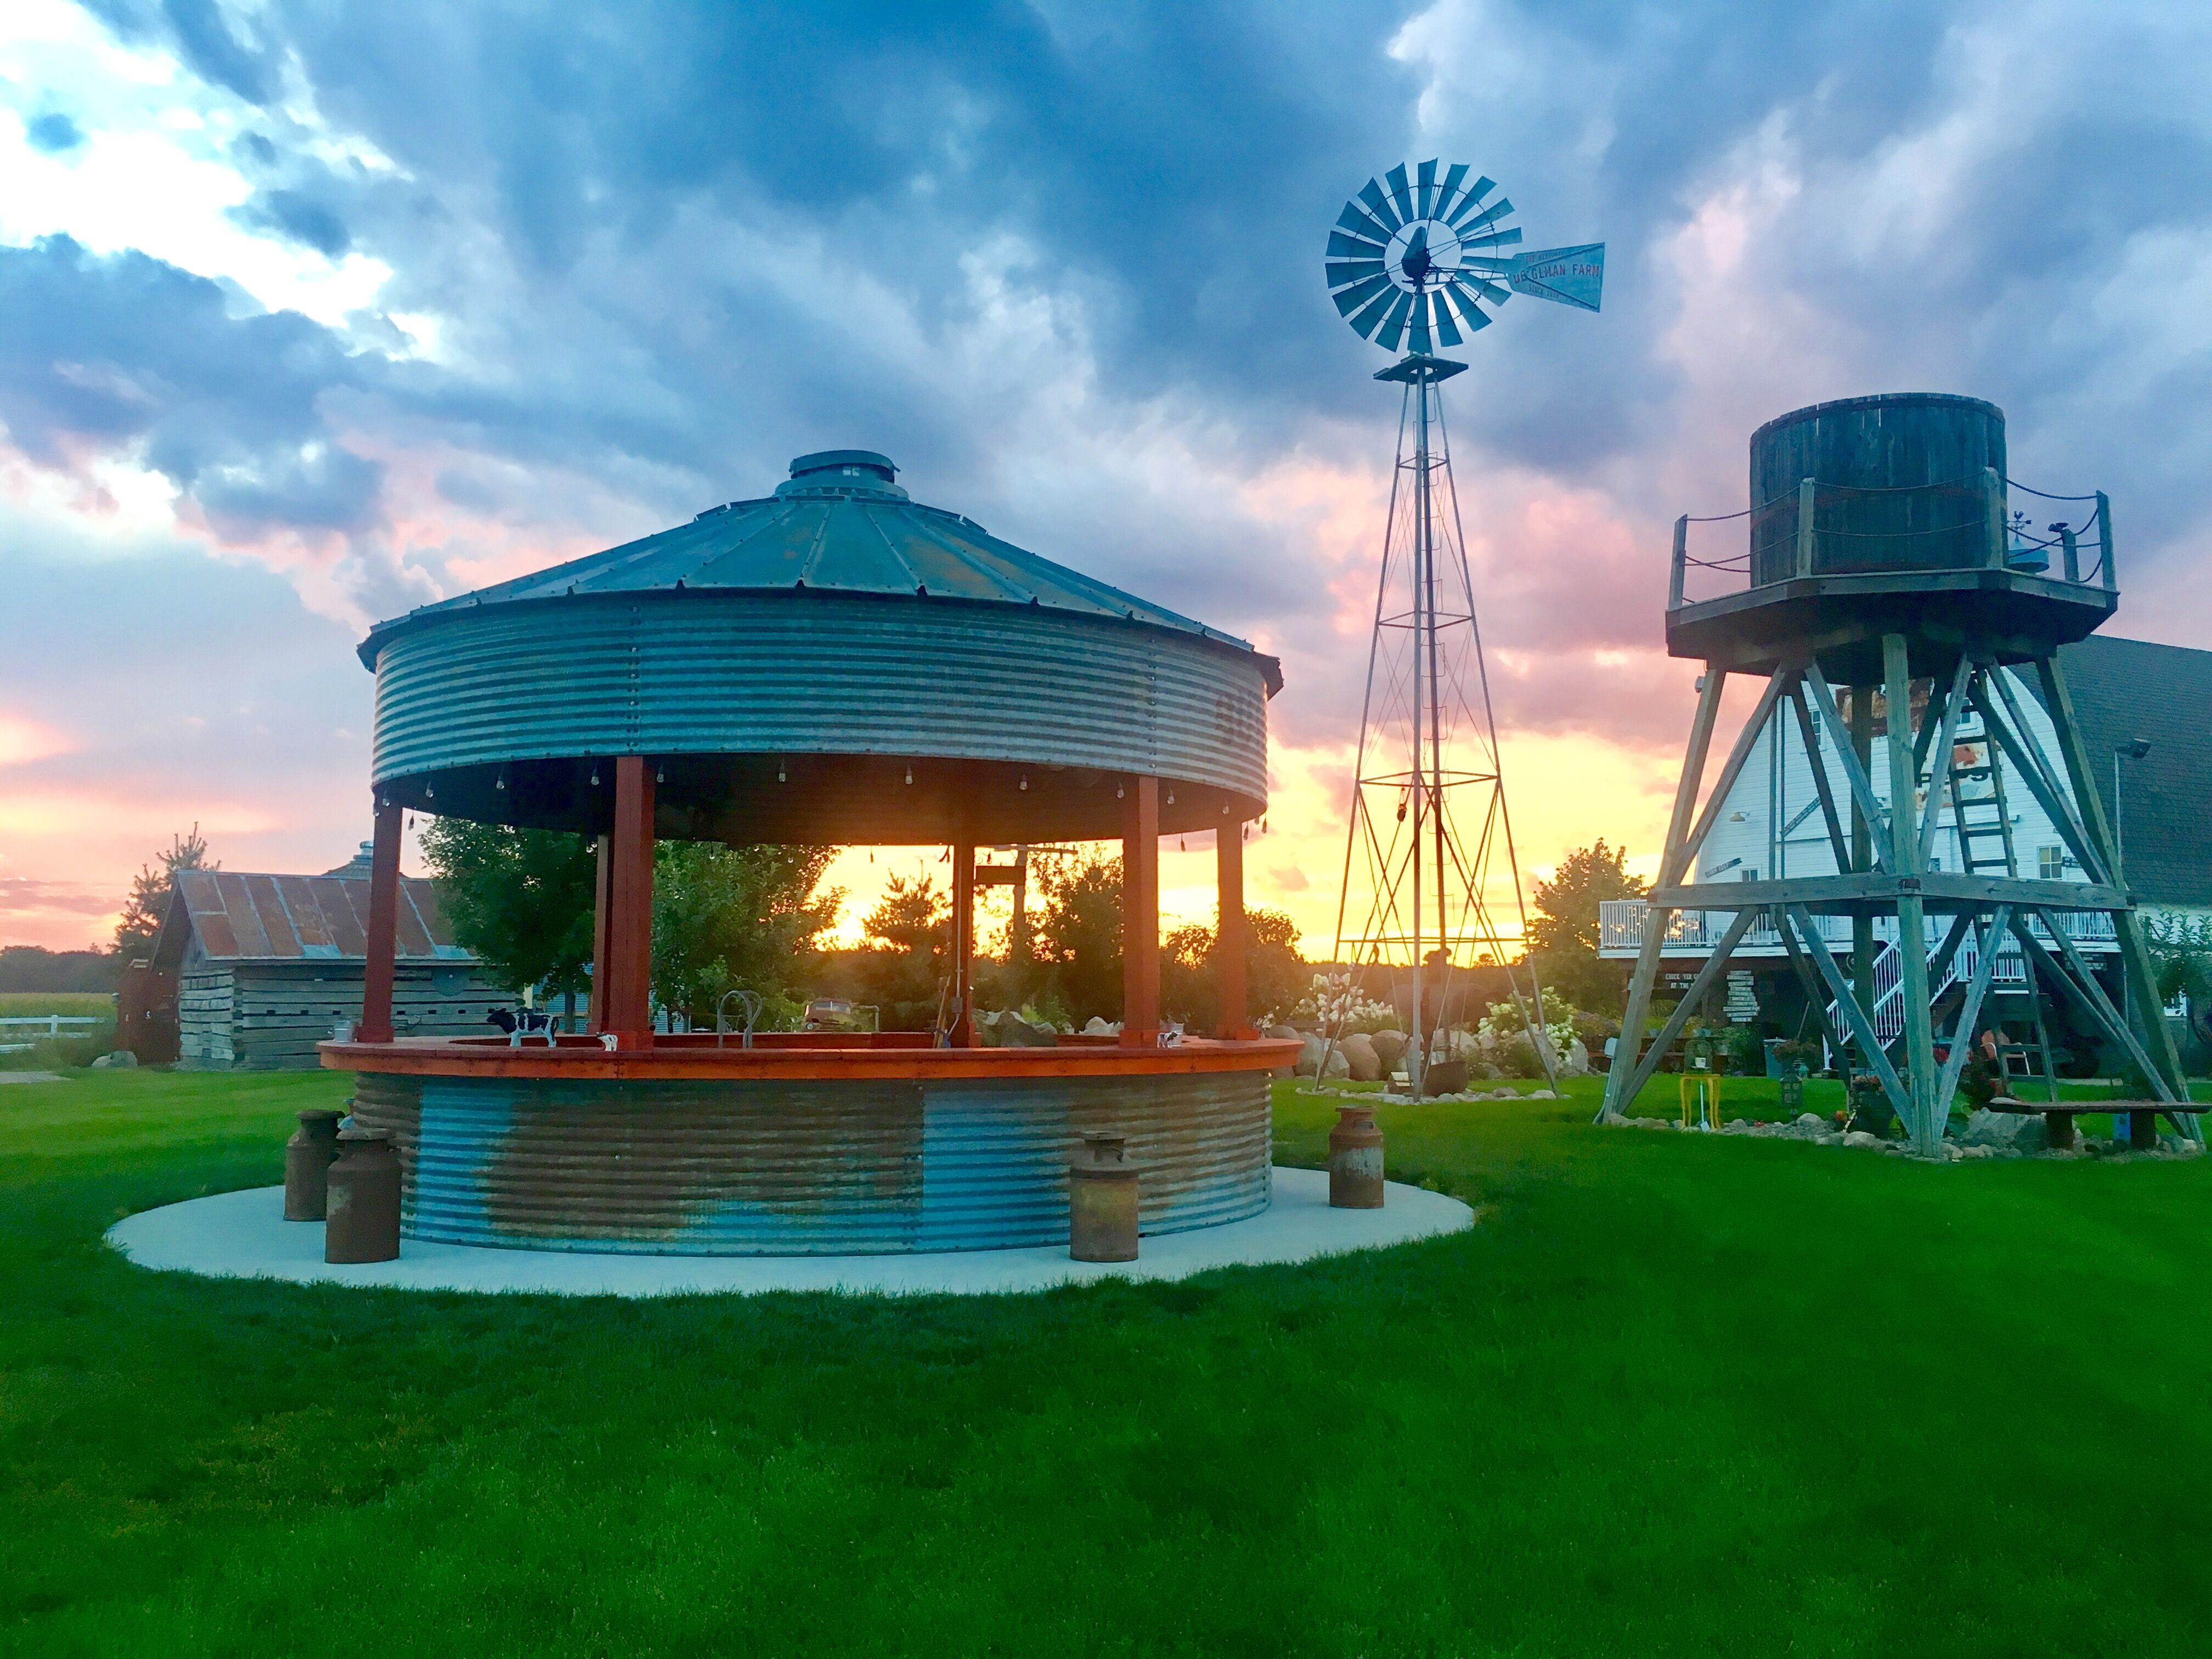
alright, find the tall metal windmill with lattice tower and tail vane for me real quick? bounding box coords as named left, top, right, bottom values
left=1327, top=161, right=1606, bottom=1097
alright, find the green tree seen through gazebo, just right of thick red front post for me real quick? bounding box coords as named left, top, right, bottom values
left=652, top=840, right=845, bottom=1026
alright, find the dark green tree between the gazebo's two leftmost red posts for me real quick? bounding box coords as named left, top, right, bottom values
left=422, top=819, right=600, bottom=993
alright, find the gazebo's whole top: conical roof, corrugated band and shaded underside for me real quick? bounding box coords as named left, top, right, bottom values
left=360, top=449, right=1281, bottom=845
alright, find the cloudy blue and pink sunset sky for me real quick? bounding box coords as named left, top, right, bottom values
left=0, top=0, right=2212, bottom=947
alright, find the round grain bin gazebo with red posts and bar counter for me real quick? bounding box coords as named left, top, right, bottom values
left=323, top=449, right=1294, bottom=1254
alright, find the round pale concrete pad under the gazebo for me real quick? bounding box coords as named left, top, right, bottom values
left=109, top=1168, right=1475, bottom=1296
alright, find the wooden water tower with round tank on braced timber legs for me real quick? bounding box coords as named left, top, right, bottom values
left=1601, top=392, right=2201, bottom=1153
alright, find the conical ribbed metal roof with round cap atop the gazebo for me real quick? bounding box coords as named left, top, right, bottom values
left=360, top=449, right=1281, bottom=690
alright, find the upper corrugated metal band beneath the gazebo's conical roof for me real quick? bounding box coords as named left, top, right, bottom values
left=374, top=593, right=1267, bottom=799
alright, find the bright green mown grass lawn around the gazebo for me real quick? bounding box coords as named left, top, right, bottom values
left=0, top=1073, right=2212, bottom=1659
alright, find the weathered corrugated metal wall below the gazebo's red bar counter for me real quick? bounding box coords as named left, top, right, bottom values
left=354, top=1073, right=1269, bottom=1256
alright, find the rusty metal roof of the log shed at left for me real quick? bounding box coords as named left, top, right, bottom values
left=153, top=867, right=476, bottom=971
